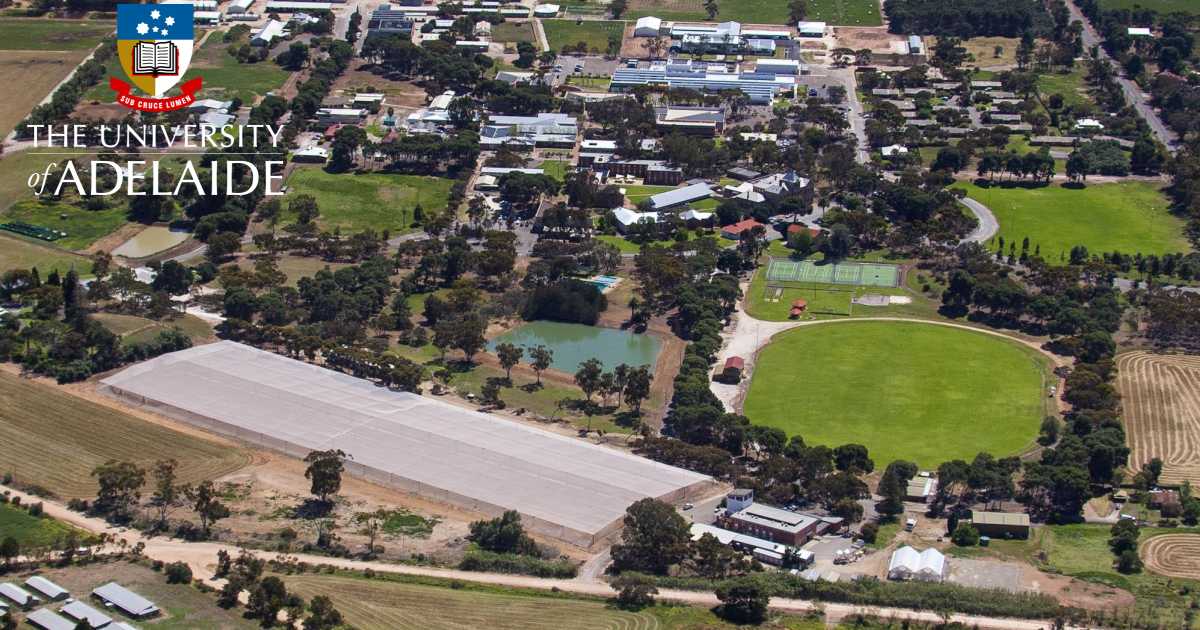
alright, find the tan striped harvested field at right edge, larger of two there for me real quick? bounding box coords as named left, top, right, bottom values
left=1117, top=352, right=1200, bottom=486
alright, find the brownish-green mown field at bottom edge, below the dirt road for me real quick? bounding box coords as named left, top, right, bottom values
left=284, top=575, right=661, bottom=630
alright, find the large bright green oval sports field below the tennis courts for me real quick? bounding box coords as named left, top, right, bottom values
left=745, top=322, right=1046, bottom=468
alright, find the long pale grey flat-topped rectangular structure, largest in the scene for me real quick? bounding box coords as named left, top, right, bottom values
left=103, top=341, right=709, bottom=547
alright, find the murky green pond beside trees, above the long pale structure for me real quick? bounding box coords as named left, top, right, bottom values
left=487, top=322, right=661, bottom=374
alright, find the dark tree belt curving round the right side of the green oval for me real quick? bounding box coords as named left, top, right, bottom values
left=926, top=245, right=1129, bottom=522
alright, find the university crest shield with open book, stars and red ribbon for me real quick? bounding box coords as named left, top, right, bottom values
left=108, top=4, right=202, bottom=112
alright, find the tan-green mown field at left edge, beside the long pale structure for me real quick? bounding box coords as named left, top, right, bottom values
left=0, top=369, right=251, bottom=498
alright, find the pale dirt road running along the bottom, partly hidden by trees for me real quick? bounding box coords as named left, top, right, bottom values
left=0, top=486, right=1070, bottom=630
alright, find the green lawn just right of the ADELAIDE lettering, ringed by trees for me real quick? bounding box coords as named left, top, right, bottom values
left=288, top=167, right=454, bottom=235
